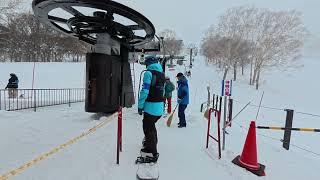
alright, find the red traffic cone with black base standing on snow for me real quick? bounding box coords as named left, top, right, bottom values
left=232, top=121, right=265, bottom=176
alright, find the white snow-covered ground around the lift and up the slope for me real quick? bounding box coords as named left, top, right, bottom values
left=0, top=57, right=320, bottom=180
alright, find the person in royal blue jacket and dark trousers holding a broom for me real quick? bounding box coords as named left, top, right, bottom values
left=177, top=73, right=189, bottom=128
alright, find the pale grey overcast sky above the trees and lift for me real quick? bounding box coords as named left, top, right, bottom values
left=25, top=0, right=320, bottom=44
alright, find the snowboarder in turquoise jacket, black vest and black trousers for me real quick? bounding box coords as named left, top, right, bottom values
left=136, top=56, right=165, bottom=163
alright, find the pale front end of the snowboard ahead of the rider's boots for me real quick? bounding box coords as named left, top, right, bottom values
left=137, top=163, right=159, bottom=180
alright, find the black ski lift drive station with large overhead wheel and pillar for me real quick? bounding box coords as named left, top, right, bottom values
left=32, top=0, right=165, bottom=113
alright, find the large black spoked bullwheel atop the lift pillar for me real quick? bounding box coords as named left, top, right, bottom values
left=32, top=0, right=155, bottom=46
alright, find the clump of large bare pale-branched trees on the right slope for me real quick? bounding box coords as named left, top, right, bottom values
left=202, top=7, right=307, bottom=89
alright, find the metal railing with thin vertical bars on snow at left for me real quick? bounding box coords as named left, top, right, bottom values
left=0, top=88, right=85, bottom=111
